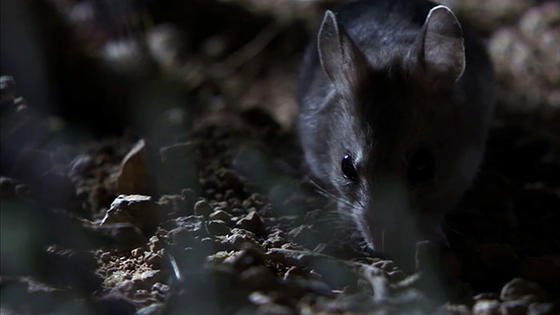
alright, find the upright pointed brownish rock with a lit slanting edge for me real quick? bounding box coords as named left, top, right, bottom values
left=117, top=139, right=151, bottom=194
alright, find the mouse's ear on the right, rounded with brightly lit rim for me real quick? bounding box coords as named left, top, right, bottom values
left=415, top=5, right=465, bottom=84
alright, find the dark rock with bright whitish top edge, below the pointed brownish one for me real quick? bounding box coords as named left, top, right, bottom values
left=101, top=195, right=159, bottom=232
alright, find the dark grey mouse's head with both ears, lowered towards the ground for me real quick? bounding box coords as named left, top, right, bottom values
left=303, top=6, right=484, bottom=251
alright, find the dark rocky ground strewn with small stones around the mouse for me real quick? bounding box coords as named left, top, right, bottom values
left=0, top=0, right=560, bottom=314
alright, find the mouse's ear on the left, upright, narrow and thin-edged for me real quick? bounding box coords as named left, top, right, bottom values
left=317, top=10, right=367, bottom=92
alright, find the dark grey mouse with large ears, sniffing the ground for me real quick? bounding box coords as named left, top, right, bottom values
left=297, top=0, right=495, bottom=253
